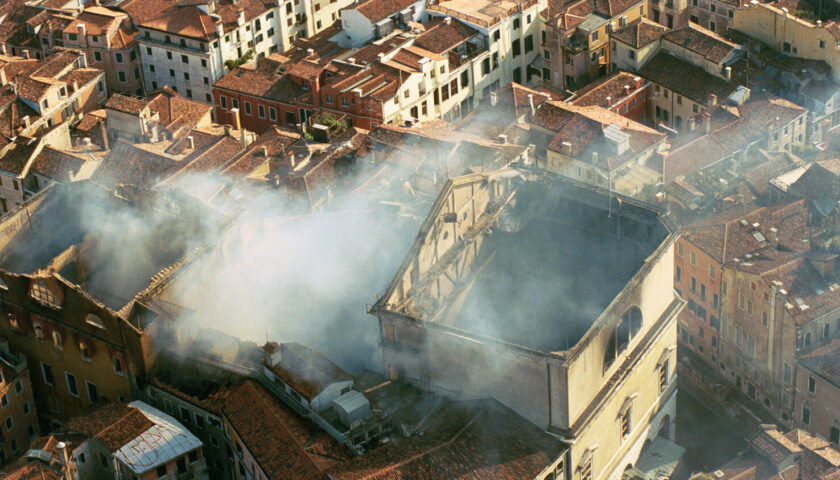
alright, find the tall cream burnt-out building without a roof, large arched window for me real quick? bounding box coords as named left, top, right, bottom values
left=370, top=168, right=683, bottom=480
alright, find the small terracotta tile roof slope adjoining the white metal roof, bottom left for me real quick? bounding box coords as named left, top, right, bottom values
left=64, top=402, right=154, bottom=453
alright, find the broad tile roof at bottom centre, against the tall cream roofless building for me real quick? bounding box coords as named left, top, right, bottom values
left=329, top=400, right=565, bottom=480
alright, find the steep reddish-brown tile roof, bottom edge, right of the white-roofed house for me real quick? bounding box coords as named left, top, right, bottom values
left=222, top=380, right=346, bottom=480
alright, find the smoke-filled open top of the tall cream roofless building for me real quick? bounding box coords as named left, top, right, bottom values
left=383, top=172, right=669, bottom=352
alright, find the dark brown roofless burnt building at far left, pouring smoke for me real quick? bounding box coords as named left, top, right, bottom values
left=0, top=181, right=220, bottom=430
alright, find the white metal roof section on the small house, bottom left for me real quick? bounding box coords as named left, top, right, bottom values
left=114, top=401, right=202, bottom=475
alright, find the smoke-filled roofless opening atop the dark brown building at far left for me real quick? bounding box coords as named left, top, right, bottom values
left=0, top=182, right=220, bottom=310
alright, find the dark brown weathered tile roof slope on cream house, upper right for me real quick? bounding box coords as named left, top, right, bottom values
left=639, top=51, right=737, bottom=104
